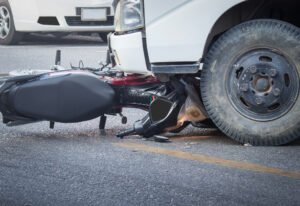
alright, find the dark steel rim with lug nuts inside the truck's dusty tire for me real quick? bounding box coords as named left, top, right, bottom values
left=226, top=49, right=299, bottom=121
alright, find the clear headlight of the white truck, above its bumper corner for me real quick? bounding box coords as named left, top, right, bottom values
left=115, top=0, right=144, bottom=32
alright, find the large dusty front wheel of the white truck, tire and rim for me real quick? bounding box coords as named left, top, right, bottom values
left=201, top=19, right=300, bottom=146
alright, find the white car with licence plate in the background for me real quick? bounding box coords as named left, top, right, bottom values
left=0, top=0, right=114, bottom=44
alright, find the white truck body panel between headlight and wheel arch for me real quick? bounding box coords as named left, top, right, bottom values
left=145, top=0, right=243, bottom=63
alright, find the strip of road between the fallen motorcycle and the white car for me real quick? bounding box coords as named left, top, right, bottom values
left=0, top=35, right=106, bottom=73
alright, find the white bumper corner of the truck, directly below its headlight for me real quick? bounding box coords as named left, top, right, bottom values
left=109, top=32, right=151, bottom=74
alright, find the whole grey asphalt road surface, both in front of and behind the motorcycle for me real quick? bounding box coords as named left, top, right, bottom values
left=0, top=37, right=300, bottom=206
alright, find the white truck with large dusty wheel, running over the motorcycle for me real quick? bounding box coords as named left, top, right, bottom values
left=110, top=0, right=300, bottom=145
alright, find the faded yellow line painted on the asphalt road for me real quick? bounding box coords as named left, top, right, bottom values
left=115, top=143, right=300, bottom=179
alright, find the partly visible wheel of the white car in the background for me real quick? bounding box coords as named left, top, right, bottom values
left=0, top=0, right=22, bottom=45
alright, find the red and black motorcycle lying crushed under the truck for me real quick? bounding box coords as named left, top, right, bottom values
left=0, top=51, right=209, bottom=138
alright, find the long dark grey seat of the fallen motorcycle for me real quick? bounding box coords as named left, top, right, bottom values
left=0, top=71, right=115, bottom=123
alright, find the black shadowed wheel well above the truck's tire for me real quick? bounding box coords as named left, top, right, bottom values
left=203, top=0, right=300, bottom=57
